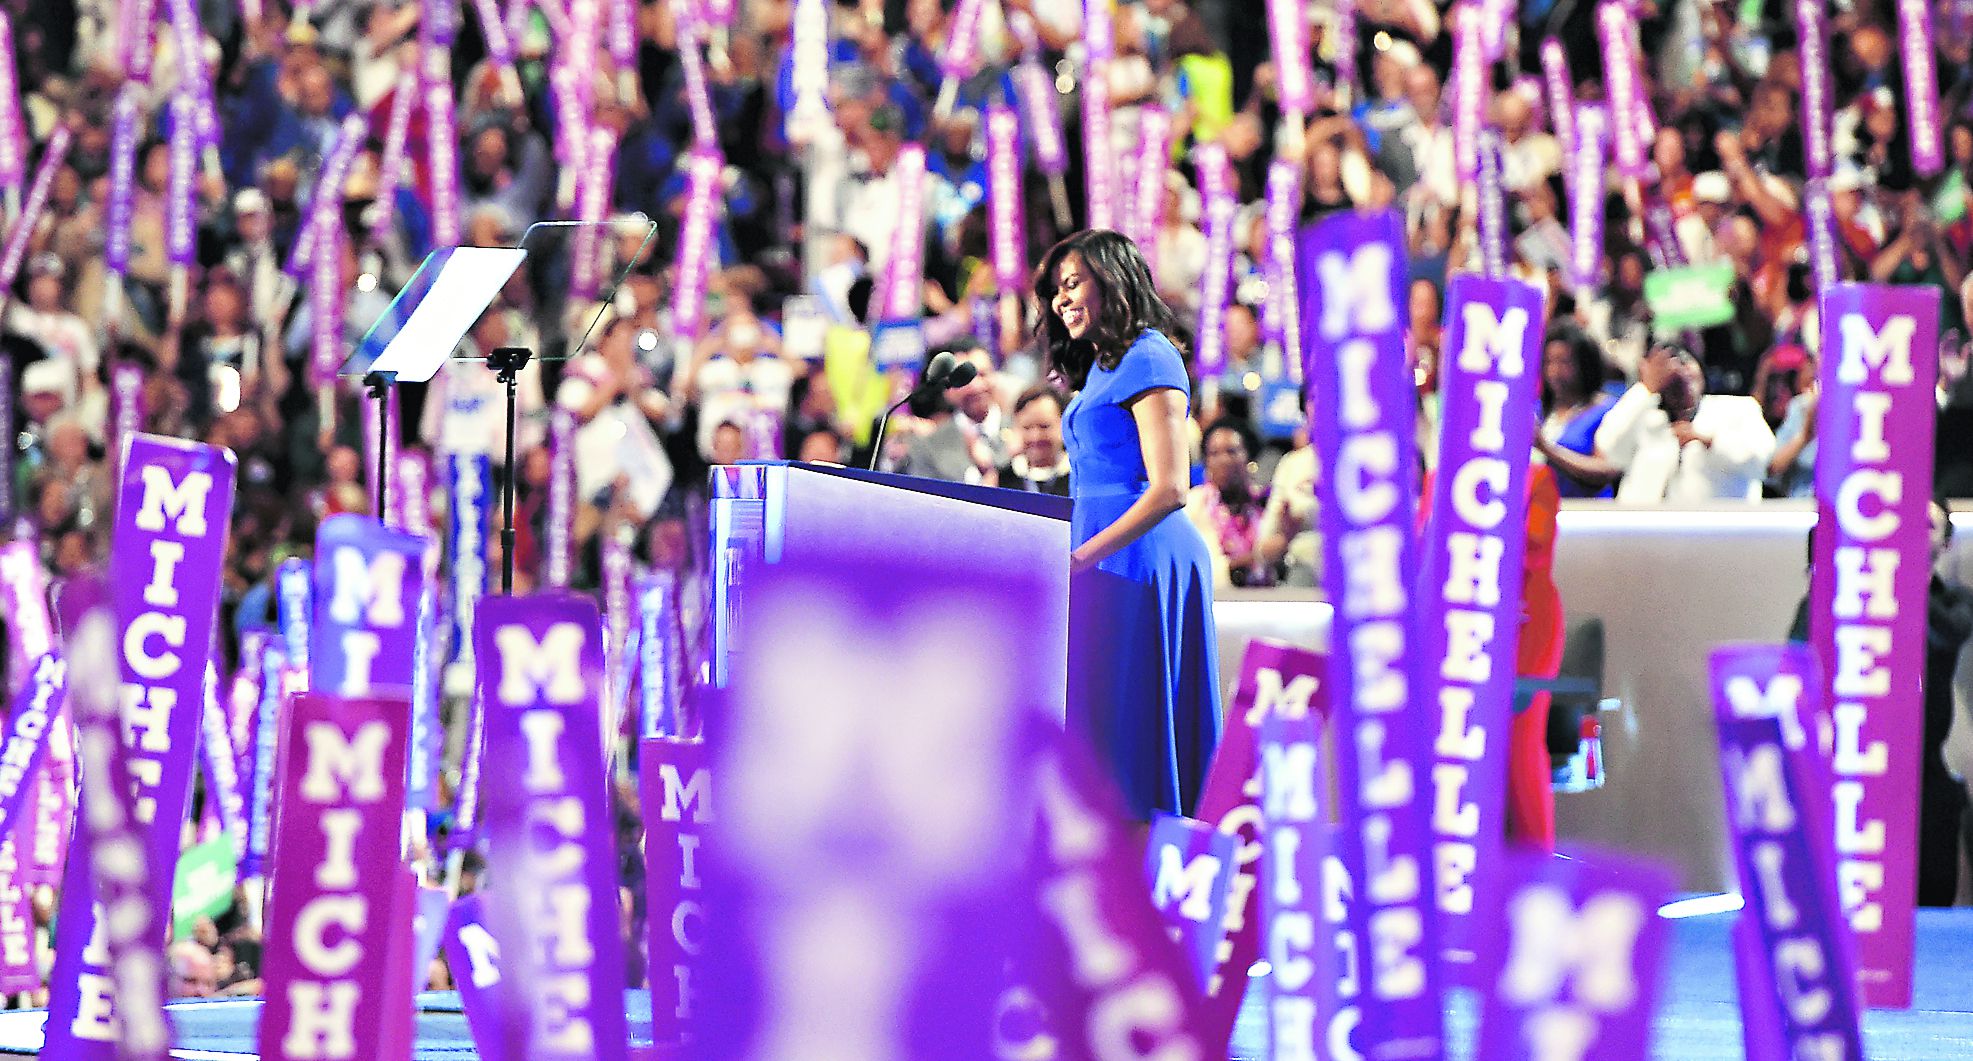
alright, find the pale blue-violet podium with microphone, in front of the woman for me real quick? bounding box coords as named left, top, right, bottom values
left=706, top=461, right=1069, bottom=720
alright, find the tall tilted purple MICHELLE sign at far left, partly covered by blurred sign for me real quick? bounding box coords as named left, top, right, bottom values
left=47, top=434, right=235, bottom=1059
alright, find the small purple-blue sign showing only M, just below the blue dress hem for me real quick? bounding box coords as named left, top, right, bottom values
left=1144, top=811, right=1241, bottom=992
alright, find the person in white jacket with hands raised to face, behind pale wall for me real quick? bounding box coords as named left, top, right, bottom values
left=1596, top=343, right=1774, bottom=503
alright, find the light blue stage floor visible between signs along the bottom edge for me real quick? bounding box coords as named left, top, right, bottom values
left=0, top=909, right=1973, bottom=1061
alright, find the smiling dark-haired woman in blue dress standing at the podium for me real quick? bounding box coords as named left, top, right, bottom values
left=1034, top=231, right=1219, bottom=820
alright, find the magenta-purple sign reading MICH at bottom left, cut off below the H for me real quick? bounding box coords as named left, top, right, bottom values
left=260, top=692, right=412, bottom=1061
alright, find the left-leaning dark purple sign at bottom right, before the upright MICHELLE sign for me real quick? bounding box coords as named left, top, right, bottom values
left=1711, top=645, right=1864, bottom=1057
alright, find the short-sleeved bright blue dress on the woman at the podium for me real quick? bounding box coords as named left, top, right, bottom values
left=1061, top=331, right=1219, bottom=820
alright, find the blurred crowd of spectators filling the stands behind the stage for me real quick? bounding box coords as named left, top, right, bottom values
left=0, top=0, right=1973, bottom=986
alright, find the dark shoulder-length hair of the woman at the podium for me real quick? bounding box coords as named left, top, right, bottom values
left=1034, top=229, right=1190, bottom=390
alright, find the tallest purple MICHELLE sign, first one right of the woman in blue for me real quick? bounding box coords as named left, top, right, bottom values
left=1300, top=211, right=1444, bottom=1061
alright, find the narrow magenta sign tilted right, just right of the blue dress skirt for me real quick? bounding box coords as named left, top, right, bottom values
left=1200, top=639, right=1328, bottom=1051
